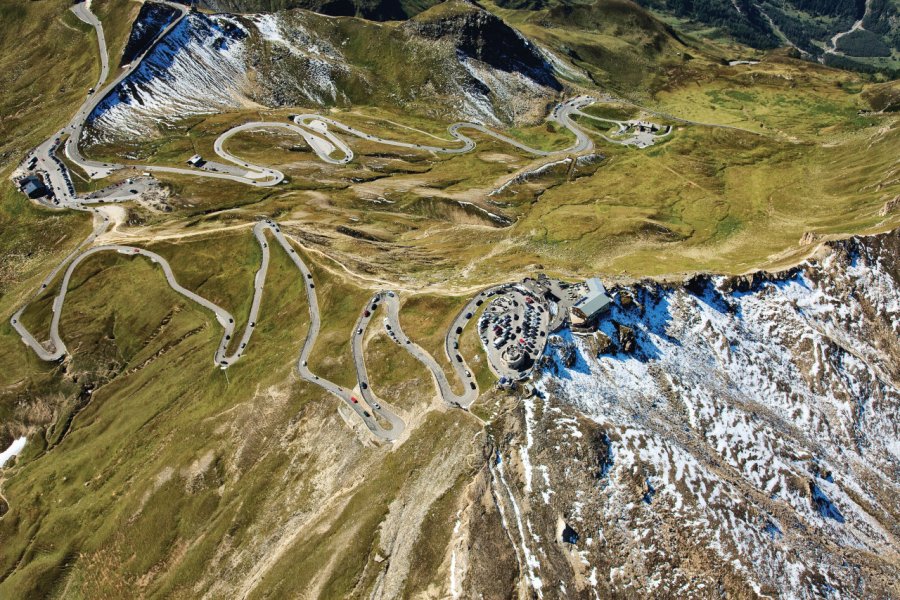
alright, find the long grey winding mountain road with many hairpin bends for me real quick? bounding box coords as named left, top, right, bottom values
left=10, top=2, right=593, bottom=441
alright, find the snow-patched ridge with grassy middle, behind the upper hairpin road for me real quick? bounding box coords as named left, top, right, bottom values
left=88, top=6, right=561, bottom=141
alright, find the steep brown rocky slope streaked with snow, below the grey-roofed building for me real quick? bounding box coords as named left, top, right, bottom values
left=472, top=233, right=900, bottom=598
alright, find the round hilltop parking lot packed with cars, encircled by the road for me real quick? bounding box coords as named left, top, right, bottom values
left=478, top=287, right=550, bottom=379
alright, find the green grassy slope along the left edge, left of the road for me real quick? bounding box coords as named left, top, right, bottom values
left=0, top=1, right=142, bottom=313
